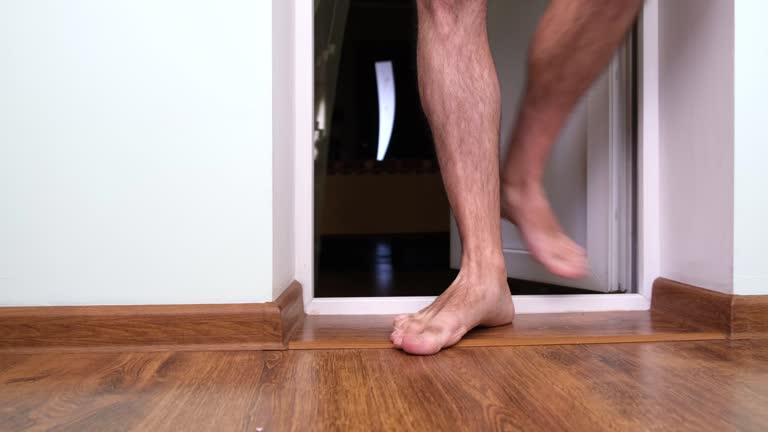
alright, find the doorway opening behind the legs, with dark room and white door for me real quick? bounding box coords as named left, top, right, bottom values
left=314, top=0, right=636, bottom=298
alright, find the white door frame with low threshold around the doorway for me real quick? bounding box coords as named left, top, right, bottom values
left=293, top=0, right=660, bottom=315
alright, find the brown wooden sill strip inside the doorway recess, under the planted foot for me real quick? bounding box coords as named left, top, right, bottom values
left=288, top=311, right=726, bottom=349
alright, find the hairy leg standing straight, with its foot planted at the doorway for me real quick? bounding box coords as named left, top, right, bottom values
left=391, top=0, right=514, bottom=354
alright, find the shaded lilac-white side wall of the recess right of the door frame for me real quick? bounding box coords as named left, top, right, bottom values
left=659, top=0, right=734, bottom=292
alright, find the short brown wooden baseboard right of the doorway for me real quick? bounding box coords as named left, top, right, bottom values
left=651, top=278, right=768, bottom=339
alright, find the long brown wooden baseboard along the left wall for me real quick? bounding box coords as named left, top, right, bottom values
left=0, top=282, right=304, bottom=352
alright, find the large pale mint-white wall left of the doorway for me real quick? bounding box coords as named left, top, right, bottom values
left=0, top=0, right=273, bottom=305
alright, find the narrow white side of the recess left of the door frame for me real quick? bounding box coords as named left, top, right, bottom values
left=272, top=0, right=295, bottom=298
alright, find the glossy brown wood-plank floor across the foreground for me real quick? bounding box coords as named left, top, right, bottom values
left=0, top=340, right=768, bottom=431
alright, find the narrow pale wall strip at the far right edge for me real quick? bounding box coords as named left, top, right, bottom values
left=733, top=0, right=768, bottom=294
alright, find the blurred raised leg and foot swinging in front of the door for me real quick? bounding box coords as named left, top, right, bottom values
left=501, top=0, right=643, bottom=278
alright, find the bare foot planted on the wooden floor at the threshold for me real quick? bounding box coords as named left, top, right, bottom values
left=390, top=265, right=515, bottom=355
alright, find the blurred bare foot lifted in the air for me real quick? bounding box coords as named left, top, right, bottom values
left=501, top=181, right=588, bottom=279
